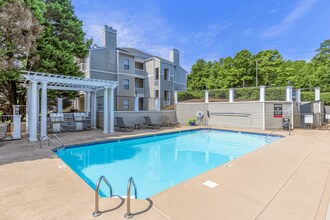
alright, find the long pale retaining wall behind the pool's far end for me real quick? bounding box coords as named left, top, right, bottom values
left=176, top=102, right=297, bottom=130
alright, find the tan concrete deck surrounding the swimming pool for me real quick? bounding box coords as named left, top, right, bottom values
left=0, top=127, right=330, bottom=220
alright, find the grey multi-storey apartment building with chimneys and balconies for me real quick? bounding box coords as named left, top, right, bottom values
left=82, top=26, right=187, bottom=111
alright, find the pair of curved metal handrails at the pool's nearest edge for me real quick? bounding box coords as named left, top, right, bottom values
left=93, top=176, right=137, bottom=219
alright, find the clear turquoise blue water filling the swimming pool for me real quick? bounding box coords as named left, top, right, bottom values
left=57, top=130, right=280, bottom=198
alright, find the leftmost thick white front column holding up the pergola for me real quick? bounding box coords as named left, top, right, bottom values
left=29, top=80, right=38, bottom=142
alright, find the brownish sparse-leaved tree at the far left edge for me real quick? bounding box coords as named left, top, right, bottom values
left=0, top=0, right=41, bottom=114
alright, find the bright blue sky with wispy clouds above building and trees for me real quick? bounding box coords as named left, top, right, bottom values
left=72, top=0, right=330, bottom=70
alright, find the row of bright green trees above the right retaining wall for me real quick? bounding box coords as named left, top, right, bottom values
left=187, top=40, right=330, bottom=92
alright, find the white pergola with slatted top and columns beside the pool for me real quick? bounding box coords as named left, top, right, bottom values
left=21, top=71, right=118, bottom=142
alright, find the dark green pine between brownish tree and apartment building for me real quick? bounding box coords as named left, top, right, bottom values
left=29, top=0, right=88, bottom=76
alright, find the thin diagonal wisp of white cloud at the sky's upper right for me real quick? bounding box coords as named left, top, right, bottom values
left=262, top=0, right=317, bottom=37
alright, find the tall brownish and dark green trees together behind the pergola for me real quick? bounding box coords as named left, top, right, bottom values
left=0, top=0, right=91, bottom=114
